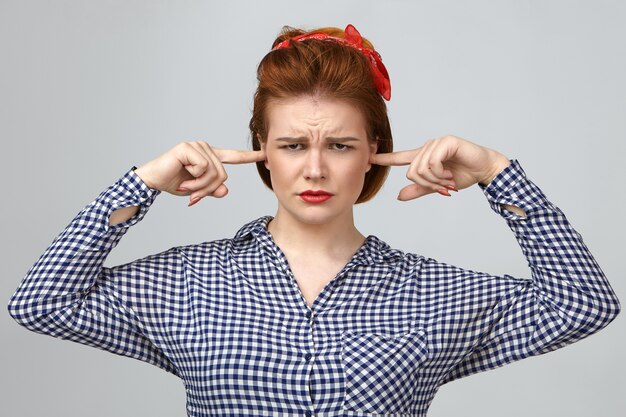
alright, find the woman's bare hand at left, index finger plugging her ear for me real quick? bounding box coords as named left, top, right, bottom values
left=135, top=141, right=265, bottom=206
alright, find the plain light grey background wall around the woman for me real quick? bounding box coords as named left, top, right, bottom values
left=0, top=0, right=626, bottom=417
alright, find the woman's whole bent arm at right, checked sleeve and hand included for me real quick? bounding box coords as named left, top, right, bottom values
left=371, top=136, right=620, bottom=382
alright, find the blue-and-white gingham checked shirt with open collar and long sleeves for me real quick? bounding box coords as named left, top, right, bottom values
left=9, top=161, right=620, bottom=417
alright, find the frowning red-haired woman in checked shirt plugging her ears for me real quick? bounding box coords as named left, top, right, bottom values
left=9, top=25, right=620, bottom=417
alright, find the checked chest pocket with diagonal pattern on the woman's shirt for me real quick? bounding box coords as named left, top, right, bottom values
left=341, top=322, right=428, bottom=414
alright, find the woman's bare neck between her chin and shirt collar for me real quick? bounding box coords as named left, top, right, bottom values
left=267, top=209, right=365, bottom=260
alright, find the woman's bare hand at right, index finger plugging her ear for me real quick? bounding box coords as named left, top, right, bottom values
left=370, top=135, right=510, bottom=201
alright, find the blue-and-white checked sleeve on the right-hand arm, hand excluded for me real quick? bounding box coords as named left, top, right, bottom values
left=422, top=161, right=620, bottom=382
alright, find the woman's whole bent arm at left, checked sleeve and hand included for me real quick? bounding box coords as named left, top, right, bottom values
left=8, top=142, right=263, bottom=374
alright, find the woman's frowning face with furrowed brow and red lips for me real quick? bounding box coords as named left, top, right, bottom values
left=262, top=97, right=376, bottom=224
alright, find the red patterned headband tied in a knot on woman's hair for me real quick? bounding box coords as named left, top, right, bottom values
left=272, top=25, right=391, bottom=101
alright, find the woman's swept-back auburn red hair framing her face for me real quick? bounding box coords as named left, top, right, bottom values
left=250, top=26, right=393, bottom=203
